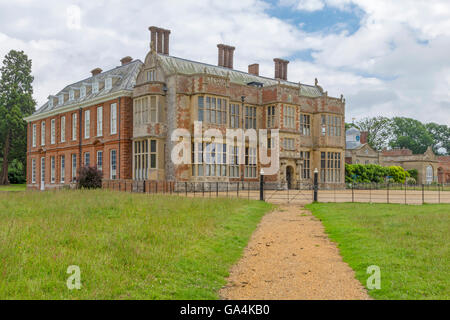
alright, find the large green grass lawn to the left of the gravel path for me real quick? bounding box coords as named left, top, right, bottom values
left=0, top=190, right=271, bottom=299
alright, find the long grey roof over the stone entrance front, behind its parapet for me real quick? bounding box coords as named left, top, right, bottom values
left=158, top=54, right=322, bottom=98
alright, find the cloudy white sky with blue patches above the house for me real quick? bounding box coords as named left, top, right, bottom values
left=0, top=0, right=450, bottom=125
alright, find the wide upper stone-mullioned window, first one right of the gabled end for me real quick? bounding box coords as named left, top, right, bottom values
left=198, top=96, right=227, bottom=124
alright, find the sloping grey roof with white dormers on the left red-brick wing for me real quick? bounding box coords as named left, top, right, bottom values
left=33, top=60, right=143, bottom=115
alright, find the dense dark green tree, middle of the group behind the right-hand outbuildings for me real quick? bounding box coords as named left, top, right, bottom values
left=389, top=117, right=434, bottom=154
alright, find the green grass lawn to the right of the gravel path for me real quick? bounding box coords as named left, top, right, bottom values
left=307, top=203, right=450, bottom=299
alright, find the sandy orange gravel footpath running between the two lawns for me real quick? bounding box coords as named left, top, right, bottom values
left=220, top=206, right=369, bottom=300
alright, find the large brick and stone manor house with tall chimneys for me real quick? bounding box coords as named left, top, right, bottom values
left=25, top=27, right=345, bottom=190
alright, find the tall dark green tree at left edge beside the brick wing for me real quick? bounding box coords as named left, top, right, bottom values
left=0, top=50, right=36, bottom=184
